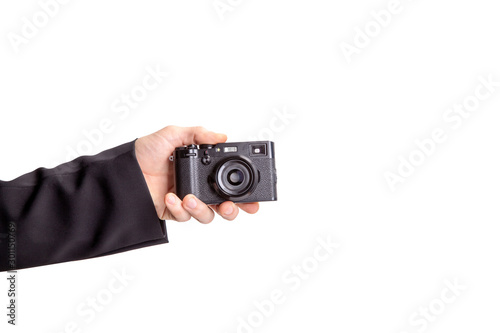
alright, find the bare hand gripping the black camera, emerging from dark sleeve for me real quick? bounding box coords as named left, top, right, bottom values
left=135, top=126, right=259, bottom=223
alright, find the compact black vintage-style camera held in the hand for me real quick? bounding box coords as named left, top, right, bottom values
left=173, top=141, right=277, bottom=204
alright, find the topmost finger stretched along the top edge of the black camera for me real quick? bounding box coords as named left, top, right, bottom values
left=164, top=126, right=227, bottom=146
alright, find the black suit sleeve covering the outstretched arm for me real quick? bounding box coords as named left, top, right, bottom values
left=0, top=141, right=168, bottom=271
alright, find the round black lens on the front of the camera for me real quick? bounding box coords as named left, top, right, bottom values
left=213, top=156, right=258, bottom=200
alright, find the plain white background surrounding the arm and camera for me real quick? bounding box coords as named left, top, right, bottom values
left=0, top=0, right=500, bottom=333
